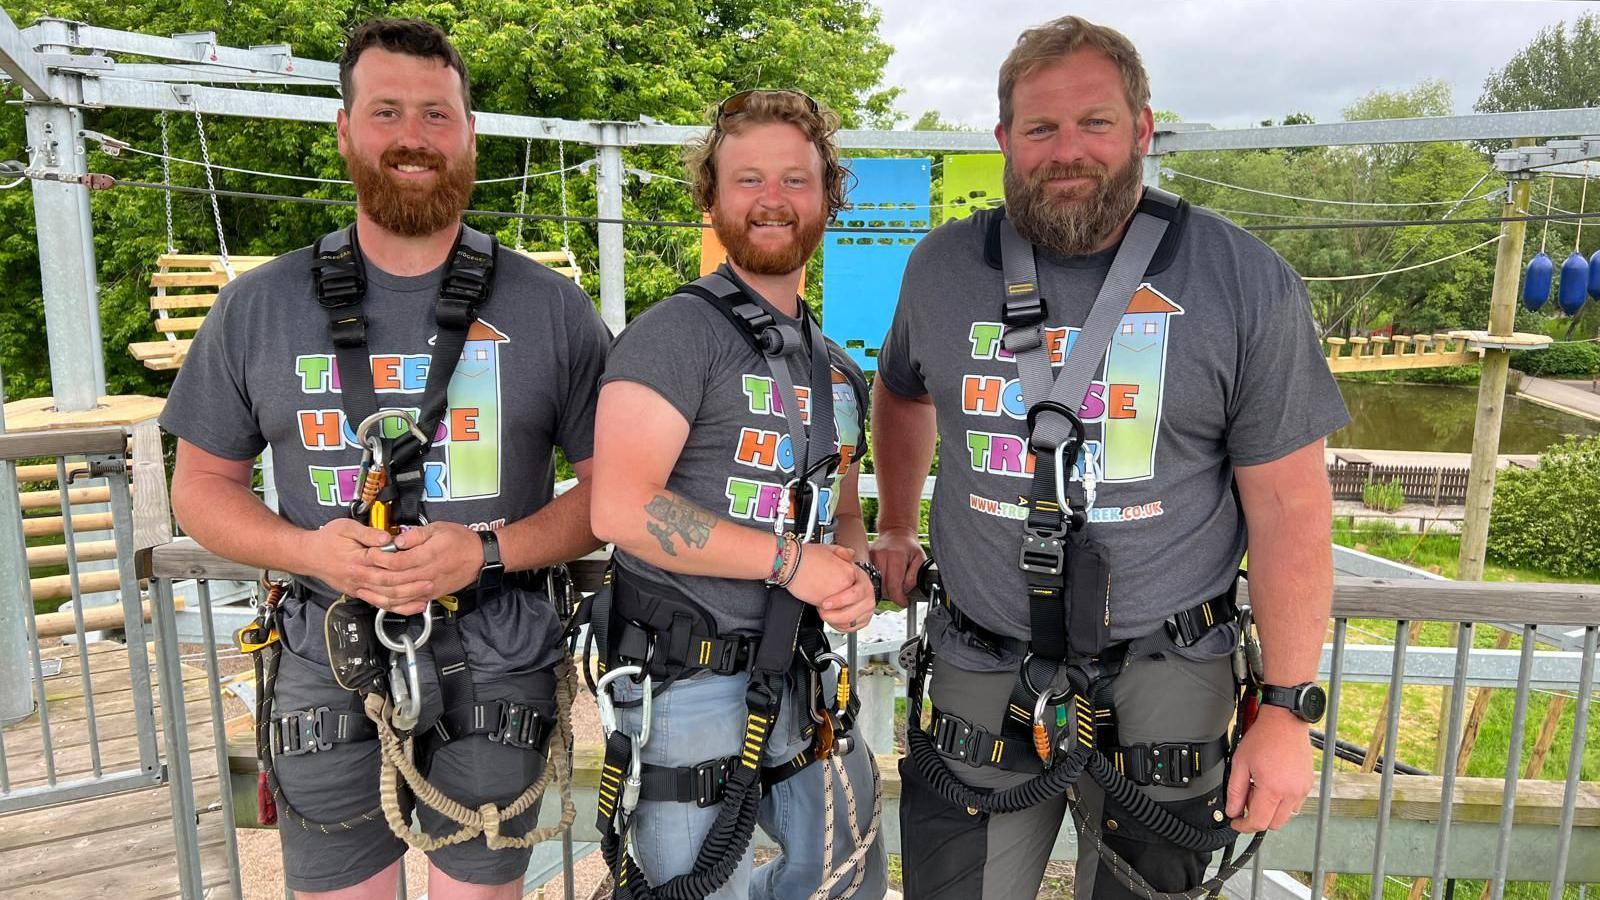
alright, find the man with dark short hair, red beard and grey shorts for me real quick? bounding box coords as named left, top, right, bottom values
left=162, top=19, right=610, bottom=898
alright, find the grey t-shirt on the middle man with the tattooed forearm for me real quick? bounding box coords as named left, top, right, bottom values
left=602, top=266, right=866, bottom=634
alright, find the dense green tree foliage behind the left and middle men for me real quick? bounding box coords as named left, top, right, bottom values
left=0, top=0, right=898, bottom=399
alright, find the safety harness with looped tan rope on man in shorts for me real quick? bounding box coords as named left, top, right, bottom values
left=235, top=224, right=576, bottom=850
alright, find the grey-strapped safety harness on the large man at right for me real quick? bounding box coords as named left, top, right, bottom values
left=901, top=189, right=1261, bottom=900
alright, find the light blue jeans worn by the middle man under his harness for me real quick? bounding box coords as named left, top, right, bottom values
left=613, top=659, right=888, bottom=900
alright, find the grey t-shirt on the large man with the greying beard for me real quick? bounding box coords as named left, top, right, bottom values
left=878, top=203, right=1349, bottom=665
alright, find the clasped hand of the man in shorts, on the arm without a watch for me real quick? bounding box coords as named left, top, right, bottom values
left=298, top=519, right=434, bottom=615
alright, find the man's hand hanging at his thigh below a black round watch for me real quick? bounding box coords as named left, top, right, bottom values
left=1227, top=706, right=1314, bottom=834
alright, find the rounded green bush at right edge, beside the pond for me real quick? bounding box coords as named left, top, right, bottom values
left=1488, top=437, right=1600, bottom=578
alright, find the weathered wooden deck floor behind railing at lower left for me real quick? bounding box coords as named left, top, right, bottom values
left=0, top=642, right=230, bottom=900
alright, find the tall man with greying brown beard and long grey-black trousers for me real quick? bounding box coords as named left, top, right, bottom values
left=872, top=16, right=1347, bottom=898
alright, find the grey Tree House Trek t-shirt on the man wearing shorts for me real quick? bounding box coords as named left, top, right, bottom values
left=162, top=235, right=610, bottom=669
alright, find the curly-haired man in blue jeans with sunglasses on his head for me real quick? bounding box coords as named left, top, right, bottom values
left=590, top=90, right=886, bottom=900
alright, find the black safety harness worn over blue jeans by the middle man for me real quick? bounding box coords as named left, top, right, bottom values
left=579, top=272, right=882, bottom=900
